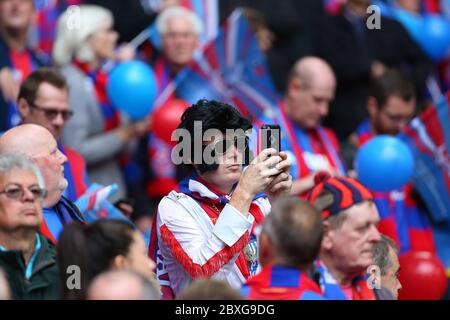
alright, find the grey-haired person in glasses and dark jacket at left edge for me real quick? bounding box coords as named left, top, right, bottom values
left=0, top=155, right=58, bottom=300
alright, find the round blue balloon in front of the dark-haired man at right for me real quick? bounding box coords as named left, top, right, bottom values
left=355, top=135, right=414, bottom=192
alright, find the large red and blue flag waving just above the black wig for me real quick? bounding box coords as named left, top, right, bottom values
left=156, top=10, right=278, bottom=124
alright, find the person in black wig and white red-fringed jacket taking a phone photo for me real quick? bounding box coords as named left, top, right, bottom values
left=149, top=100, right=292, bottom=298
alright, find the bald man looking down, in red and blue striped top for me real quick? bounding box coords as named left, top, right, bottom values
left=272, top=57, right=345, bottom=195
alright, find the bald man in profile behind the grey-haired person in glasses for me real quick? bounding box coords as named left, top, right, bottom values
left=0, top=124, right=84, bottom=242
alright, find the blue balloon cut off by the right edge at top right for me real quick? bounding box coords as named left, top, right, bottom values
left=422, top=14, right=450, bottom=62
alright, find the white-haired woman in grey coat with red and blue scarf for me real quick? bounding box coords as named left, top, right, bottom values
left=53, top=5, right=149, bottom=201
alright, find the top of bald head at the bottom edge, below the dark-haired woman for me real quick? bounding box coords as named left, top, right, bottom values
left=88, top=270, right=160, bottom=300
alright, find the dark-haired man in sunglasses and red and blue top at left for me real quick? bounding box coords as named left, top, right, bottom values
left=17, top=68, right=88, bottom=201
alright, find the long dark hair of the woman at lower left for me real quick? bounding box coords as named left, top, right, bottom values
left=57, top=219, right=134, bottom=300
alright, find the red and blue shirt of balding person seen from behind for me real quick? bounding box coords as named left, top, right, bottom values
left=241, top=266, right=323, bottom=300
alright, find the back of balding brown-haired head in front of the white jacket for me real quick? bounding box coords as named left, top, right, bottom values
left=262, top=197, right=323, bottom=268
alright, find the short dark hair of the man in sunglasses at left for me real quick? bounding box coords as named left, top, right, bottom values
left=17, top=68, right=68, bottom=103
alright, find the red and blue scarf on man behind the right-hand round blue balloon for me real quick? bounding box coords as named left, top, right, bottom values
left=356, top=120, right=436, bottom=254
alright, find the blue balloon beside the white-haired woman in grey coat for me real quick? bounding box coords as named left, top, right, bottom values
left=106, top=61, right=157, bottom=120
